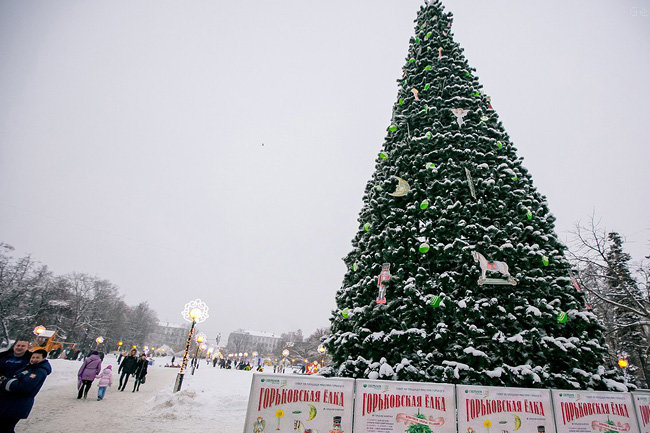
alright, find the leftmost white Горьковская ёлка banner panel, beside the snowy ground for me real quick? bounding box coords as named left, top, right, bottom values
left=244, top=373, right=354, bottom=433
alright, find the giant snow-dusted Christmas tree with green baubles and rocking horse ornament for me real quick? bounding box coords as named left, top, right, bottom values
left=326, top=0, right=620, bottom=389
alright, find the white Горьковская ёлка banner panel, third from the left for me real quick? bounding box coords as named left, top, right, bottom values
left=456, top=385, right=556, bottom=433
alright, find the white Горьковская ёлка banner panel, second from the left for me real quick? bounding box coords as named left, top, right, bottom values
left=354, top=379, right=456, bottom=433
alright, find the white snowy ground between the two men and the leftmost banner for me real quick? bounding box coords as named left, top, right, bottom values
left=16, top=357, right=253, bottom=433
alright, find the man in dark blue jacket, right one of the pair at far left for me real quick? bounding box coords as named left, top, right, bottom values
left=0, top=349, right=52, bottom=433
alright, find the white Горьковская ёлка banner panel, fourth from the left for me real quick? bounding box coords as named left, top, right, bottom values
left=553, top=389, right=639, bottom=433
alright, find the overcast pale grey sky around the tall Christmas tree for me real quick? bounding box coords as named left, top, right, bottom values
left=0, top=0, right=650, bottom=336
